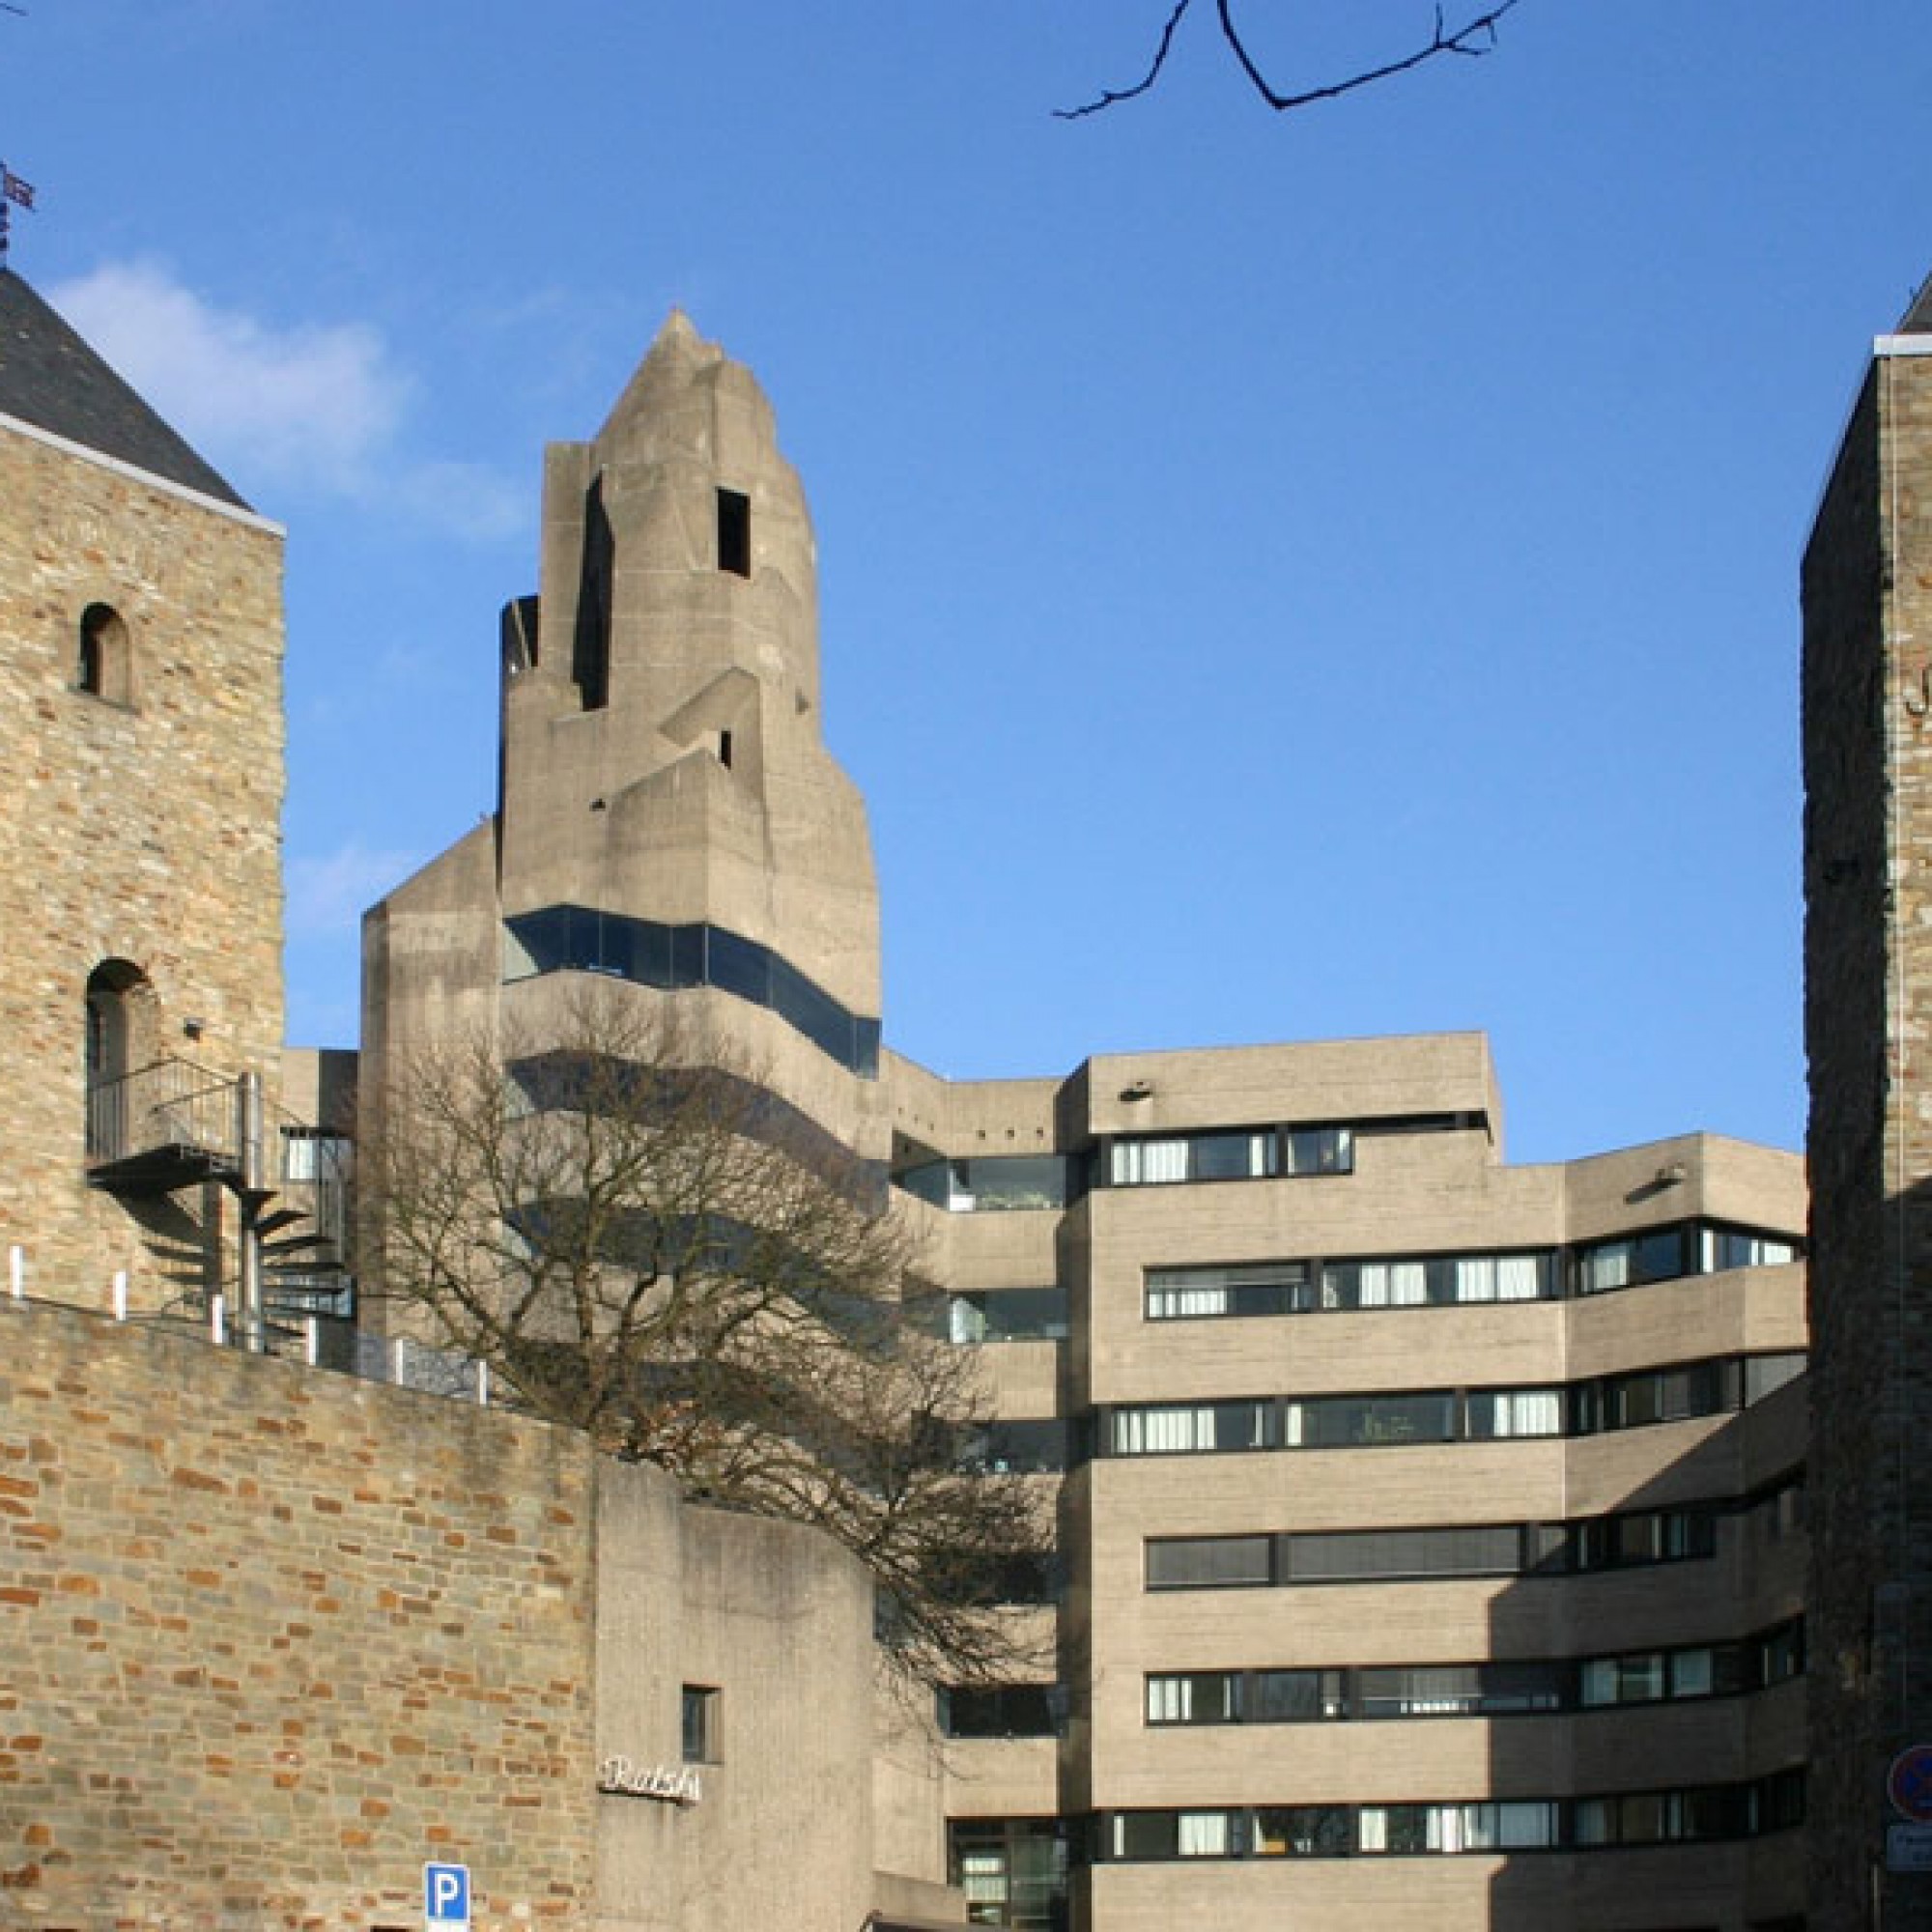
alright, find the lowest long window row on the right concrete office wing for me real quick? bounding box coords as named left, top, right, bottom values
left=1097, top=1768, right=1804, bottom=1861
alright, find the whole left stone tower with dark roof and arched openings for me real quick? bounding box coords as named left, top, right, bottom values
left=0, top=272, right=282, bottom=1308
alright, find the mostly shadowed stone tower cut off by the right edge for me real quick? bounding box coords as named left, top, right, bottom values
left=1803, top=272, right=1932, bottom=1932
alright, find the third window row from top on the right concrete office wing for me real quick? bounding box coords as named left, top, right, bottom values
left=1101, top=1354, right=1804, bottom=1457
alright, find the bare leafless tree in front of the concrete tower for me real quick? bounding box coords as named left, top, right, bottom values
left=365, top=997, right=1043, bottom=1683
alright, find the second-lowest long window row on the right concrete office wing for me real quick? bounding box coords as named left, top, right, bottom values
left=1136, top=1621, right=1804, bottom=1737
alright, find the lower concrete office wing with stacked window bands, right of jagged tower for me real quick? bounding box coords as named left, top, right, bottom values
left=904, top=1034, right=1804, bottom=1932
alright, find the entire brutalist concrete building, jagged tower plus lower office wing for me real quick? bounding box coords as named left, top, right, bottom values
left=363, top=317, right=1806, bottom=1932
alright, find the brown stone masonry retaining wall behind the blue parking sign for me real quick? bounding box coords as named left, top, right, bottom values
left=0, top=1300, right=595, bottom=1932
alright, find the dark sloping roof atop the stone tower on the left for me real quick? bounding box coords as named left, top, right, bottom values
left=0, top=269, right=247, bottom=510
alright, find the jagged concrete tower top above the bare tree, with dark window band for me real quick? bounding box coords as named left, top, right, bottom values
left=363, top=315, right=887, bottom=1186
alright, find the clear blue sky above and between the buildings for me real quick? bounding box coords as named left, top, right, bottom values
left=0, top=0, right=1932, bottom=1159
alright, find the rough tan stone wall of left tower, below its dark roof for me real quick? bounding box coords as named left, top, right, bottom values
left=0, top=423, right=282, bottom=1306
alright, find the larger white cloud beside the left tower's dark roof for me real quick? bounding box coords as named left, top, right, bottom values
left=48, top=259, right=524, bottom=539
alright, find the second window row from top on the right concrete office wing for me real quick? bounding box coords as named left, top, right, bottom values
left=1144, top=1221, right=1797, bottom=1321
